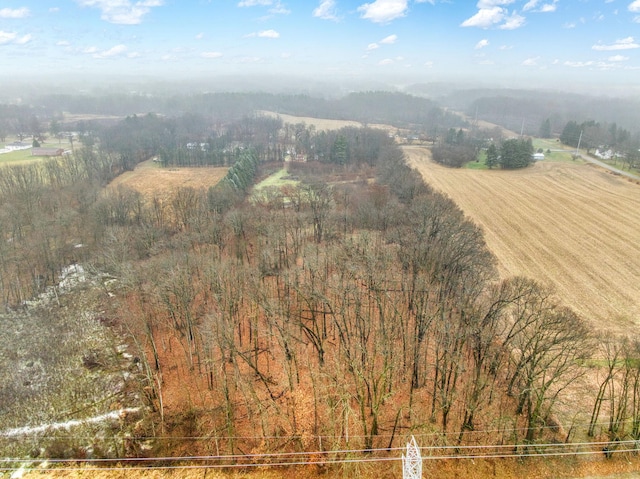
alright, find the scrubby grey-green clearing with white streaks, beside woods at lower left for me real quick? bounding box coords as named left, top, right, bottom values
left=0, top=264, right=144, bottom=458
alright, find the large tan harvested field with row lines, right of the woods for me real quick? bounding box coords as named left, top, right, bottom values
left=404, top=146, right=640, bottom=332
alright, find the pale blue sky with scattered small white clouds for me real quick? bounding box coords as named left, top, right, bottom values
left=0, top=0, right=640, bottom=88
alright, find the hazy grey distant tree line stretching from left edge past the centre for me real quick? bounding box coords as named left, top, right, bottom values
left=0, top=91, right=465, bottom=142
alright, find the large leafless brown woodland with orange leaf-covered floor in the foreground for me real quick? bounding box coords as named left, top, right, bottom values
left=0, top=90, right=640, bottom=462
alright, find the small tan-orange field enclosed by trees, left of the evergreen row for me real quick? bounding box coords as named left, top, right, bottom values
left=104, top=160, right=228, bottom=199
